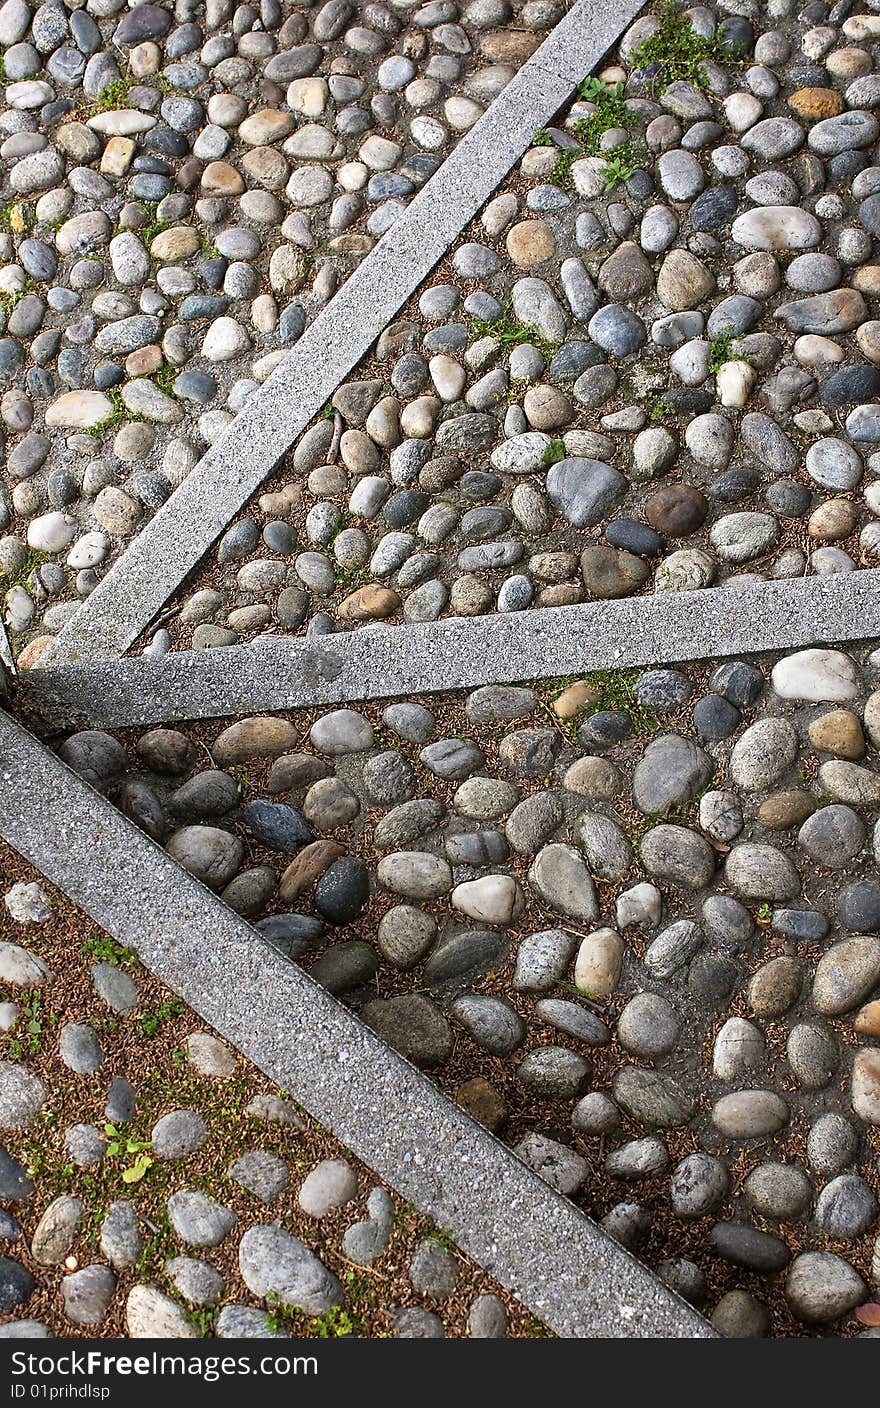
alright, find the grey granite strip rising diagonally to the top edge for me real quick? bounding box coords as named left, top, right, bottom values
left=42, top=0, right=643, bottom=665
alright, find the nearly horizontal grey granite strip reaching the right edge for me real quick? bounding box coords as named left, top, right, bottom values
left=17, top=569, right=880, bottom=734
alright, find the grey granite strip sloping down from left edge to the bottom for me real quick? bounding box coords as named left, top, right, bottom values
left=0, top=714, right=715, bottom=1339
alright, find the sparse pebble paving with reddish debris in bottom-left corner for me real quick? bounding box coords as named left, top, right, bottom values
left=0, top=846, right=546, bottom=1339
